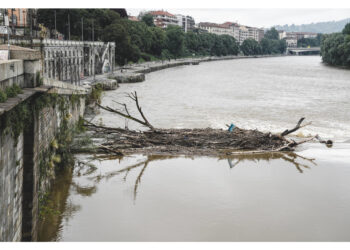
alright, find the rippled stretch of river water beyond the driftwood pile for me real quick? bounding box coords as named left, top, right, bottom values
left=96, top=56, right=350, bottom=141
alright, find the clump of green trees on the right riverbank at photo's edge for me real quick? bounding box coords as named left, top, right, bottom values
left=321, top=23, right=350, bottom=67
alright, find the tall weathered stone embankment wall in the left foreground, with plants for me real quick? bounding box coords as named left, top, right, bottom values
left=0, top=93, right=85, bottom=241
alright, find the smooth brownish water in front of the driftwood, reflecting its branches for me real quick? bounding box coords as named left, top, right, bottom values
left=39, top=148, right=350, bottom=241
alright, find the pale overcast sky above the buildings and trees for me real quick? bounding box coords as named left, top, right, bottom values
left=126, top=8, right=350, bottom=28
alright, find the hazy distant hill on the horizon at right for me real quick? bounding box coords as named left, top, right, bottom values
left=274, top=18, right=350, bottom=33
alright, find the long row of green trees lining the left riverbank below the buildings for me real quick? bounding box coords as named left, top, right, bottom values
left=38, top=9, right=286, bottom=62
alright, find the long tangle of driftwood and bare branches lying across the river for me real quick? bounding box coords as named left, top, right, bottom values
left=80, top=92, right=332, bottom=155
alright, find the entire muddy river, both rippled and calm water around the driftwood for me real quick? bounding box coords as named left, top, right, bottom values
left=39, top=56, right=350, bottom=241
